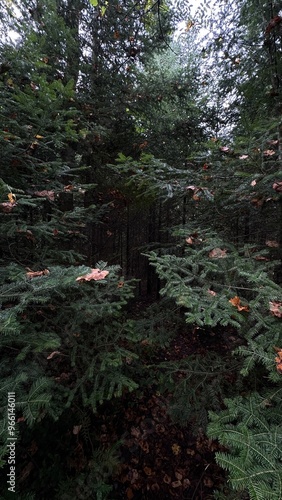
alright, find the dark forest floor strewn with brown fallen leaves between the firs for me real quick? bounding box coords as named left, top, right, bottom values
left=93, top=322, right=243, bottom=500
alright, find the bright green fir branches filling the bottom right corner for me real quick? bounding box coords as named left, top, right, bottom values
left=208, top=391, right=282, bottom=500
